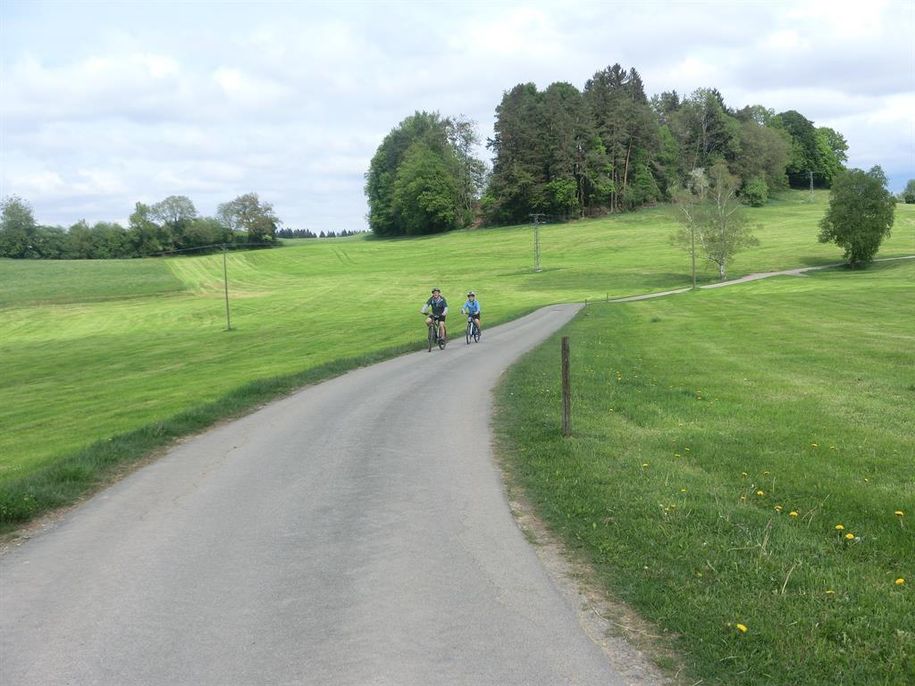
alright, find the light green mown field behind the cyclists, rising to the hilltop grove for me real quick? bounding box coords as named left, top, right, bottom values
left=0, top=193, right=915, bottom=508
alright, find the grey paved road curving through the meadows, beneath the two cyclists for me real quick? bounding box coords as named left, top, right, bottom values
left=0, top=306, right=636, bottom=686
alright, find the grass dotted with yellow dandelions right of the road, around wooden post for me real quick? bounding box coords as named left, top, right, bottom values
left=498, top=261, right=915, bottom=686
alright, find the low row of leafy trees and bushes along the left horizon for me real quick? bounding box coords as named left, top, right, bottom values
left=0, top=193, right=280, bottom=259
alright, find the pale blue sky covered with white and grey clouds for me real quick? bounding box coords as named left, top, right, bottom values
left=0, top=0, right=915, bottom=231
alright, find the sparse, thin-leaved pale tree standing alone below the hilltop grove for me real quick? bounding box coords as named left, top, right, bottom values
left=674, top=162, right=759, bottom=283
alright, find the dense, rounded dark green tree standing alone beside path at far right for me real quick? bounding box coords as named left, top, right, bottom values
left=819, top=166, right=896, bottom=268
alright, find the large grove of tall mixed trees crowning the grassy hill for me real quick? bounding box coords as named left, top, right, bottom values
left=366, top=64, right=848, bottom=236
